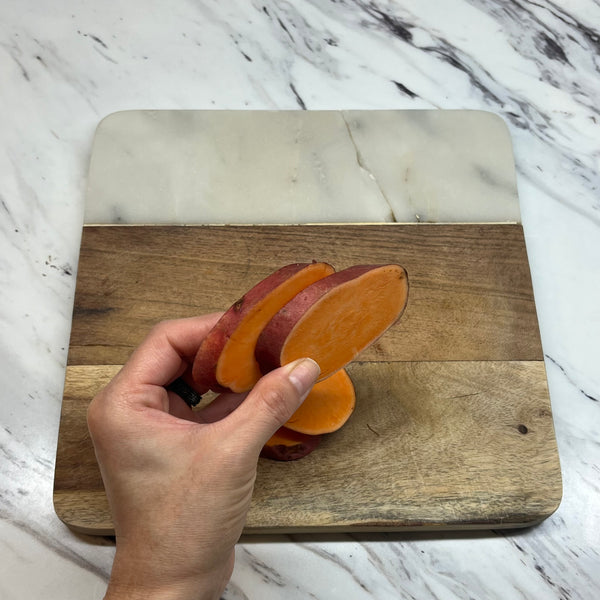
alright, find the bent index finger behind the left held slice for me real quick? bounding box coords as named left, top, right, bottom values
left=122, top=313, right=222, bottom=386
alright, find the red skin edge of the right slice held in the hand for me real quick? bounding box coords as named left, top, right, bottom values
left=255, top=265, right=408, bottom=373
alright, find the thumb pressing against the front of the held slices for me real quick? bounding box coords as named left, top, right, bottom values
left=222, top=358, right=321, bottom=454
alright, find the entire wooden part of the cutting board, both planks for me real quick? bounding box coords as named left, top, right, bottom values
left=54, top=224, right=562, bottom=534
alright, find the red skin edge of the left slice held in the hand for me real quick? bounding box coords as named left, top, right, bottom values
left=192, top=263, right=332, bottom=392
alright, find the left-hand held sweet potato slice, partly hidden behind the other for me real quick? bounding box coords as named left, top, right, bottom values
left=192, top=262, right=334, bottom=392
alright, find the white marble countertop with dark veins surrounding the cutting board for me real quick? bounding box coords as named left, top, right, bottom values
left=0, top=0, right=600, bottom=600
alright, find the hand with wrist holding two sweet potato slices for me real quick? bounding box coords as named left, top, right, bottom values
left=88, top=314, right=319, bottom=600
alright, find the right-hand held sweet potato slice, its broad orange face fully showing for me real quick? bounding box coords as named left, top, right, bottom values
left=255, top=264, right=408, bottom=380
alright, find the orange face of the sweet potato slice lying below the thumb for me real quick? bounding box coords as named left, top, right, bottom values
left=285, top=369, right=356, bottom=435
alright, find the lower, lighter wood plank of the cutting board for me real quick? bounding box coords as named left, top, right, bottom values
left=54, top=361, right=561, bottom=534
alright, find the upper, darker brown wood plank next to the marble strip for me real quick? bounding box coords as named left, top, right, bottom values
left=69, top=224, right=542, bottom=364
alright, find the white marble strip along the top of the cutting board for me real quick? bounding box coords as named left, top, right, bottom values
left=85, top=110, right=520, bottom=224
